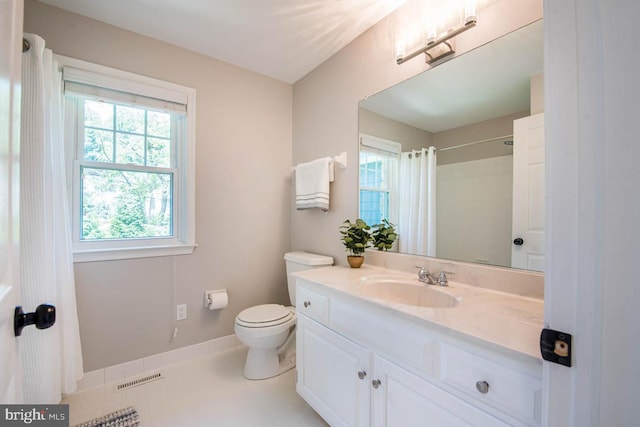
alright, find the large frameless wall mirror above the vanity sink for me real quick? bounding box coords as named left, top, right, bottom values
left=359, top=20, right=544, bottom=271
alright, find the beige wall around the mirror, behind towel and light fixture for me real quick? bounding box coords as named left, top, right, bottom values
left=291, top=0, right=542, bottom=265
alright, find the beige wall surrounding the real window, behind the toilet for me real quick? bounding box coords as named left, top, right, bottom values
left=24, top=0, right=292, bottom=371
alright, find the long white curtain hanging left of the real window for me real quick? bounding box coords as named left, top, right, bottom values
left=18, top=34, right=83, bottom=403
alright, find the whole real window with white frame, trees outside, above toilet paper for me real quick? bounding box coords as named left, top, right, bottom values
left=60, top=58, right=195, bottom=262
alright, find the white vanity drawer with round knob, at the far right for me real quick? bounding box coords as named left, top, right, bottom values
left=440, top=344, right=542, bottom=425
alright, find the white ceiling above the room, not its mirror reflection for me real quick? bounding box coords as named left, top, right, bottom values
left=39, top=0, right=405, bottom=83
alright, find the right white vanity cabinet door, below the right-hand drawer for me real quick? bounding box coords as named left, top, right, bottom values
left=371, top=356, right=508, bottom=427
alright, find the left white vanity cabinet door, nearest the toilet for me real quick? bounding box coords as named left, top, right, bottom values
left=296, top=315, right=371, bottom=427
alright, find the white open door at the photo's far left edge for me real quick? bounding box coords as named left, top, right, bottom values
left=0, top=0, right=23, bottom=403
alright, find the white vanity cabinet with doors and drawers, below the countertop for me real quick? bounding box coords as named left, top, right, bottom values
left=296, top=278, right=541, bottom=427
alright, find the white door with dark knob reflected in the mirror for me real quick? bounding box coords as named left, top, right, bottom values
left=511, top=113, right=545, bottom=271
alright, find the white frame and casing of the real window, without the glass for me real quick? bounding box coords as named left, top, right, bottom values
left=55, top=55, right=197, bottom=262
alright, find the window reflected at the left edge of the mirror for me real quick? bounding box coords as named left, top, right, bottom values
left=360, top=134, right=401, bottom=225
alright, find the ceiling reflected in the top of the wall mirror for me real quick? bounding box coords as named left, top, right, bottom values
left=360, top=20, right=544, bottom=133
